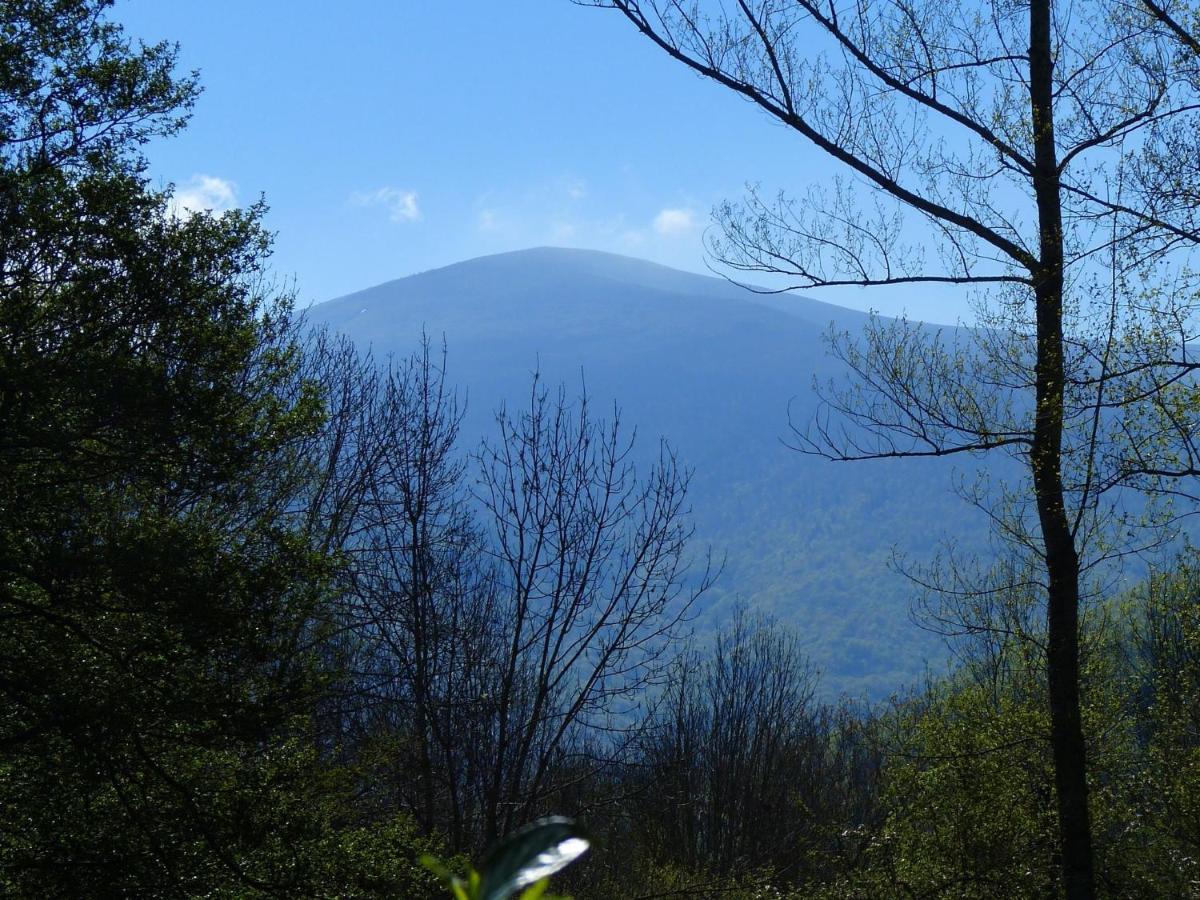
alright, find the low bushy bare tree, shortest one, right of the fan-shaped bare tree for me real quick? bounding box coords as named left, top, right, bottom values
left=634, top=608, right=877, bottom=882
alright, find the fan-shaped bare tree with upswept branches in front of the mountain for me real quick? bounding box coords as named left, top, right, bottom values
left=476, top=378, right=712, bottom=839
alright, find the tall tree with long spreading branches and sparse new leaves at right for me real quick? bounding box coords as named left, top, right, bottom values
left=593, top=0, right=1198, bottom=898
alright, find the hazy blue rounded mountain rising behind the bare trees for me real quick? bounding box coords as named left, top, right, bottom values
left=308, top=248, right=985, bottom=696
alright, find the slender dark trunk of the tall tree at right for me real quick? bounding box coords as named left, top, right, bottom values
left=1030, top=0, right=1094, bottom=900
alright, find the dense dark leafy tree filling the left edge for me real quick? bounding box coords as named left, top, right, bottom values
left=0, top=0, right=345, bottom=896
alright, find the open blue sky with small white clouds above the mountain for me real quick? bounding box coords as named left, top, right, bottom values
left=113, top=0, right=966, bottom=322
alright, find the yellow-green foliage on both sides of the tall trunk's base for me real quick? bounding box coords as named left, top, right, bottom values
left=796, top=571, right=1200, bottom=898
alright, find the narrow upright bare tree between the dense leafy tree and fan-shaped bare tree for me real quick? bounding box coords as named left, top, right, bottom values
left=292, top=332, right=503, bottom=846
